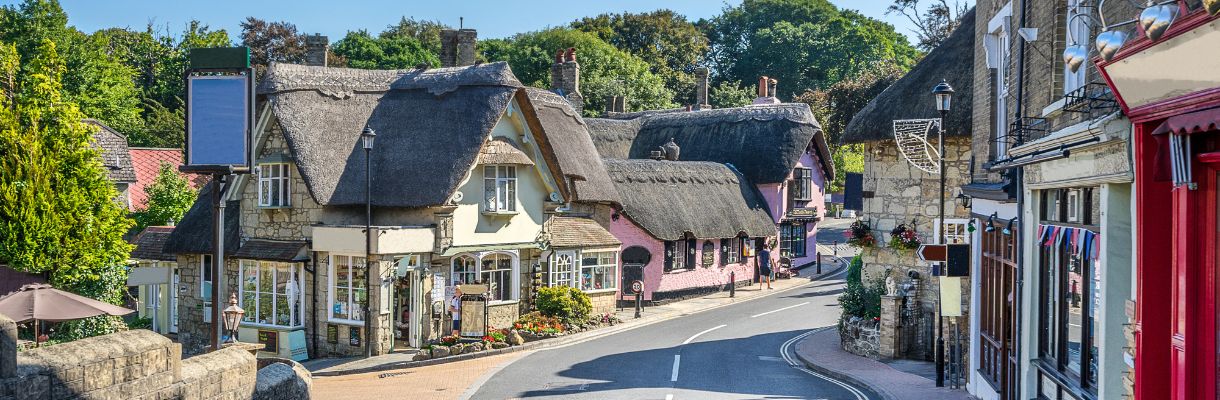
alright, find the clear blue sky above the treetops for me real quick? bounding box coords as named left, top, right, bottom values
left=7, top=0, right=932, bottom=43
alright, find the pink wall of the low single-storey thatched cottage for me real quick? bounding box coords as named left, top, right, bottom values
left=609, top=216, right=754, bottom=301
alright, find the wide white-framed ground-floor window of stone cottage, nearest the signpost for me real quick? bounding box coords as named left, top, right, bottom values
left=238, top=260, right=305, bottom=328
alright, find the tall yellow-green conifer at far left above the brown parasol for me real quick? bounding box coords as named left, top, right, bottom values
left=0, top=39, right=132, bottom=339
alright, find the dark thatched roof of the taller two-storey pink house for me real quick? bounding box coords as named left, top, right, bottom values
left=586, top=104, right=834, bottom=183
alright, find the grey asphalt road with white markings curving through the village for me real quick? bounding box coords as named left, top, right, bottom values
left=471, top=265, right=880, bottom=400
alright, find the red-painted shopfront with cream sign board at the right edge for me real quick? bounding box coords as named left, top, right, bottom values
left=1098, top=1, right=1220, bottom=400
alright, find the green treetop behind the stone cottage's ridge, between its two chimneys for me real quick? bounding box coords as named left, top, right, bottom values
left=332, top=30, right=440, bottom=70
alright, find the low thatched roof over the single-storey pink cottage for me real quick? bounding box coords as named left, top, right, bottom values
left=605, top=160, right=775, bottom=240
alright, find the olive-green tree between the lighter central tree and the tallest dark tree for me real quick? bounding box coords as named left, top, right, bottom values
left=572, top=9, right=708, bottom=104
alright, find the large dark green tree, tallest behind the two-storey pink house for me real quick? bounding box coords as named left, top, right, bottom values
left=699, top=0, right=919, bottom=98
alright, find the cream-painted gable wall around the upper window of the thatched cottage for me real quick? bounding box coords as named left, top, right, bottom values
left=453, top=101, right=551, bottom=246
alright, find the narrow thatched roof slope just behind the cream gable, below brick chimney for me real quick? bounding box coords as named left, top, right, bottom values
left=522, top=88, right=621, bottom=204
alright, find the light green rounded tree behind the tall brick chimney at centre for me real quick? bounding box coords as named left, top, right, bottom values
left=479, top=28, right=676, bottom=116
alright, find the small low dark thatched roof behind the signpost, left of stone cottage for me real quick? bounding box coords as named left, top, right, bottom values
left=162, top=183, right=242, bottom=255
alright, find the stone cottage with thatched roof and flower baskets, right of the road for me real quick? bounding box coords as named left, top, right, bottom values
left=843, top=11, right=975, bottom=360
